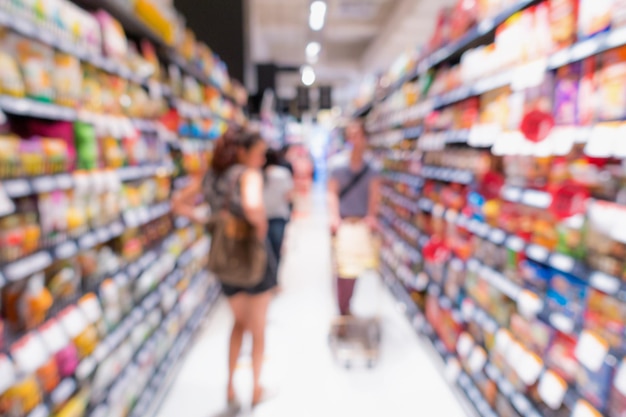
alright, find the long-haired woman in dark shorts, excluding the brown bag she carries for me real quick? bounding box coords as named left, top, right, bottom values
left=174, top=131, right=276, bottom=406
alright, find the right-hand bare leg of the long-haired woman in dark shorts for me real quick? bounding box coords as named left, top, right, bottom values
left=248, top=291, right=272, bottom=405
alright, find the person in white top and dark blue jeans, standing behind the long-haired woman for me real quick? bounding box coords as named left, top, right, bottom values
left=264, top=149, right=293, bottom=290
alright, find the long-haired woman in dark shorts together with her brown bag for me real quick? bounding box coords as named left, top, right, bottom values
left=174, top=130, right=276, bottom=406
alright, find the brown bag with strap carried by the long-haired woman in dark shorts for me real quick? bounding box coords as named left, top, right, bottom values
left=207, top=167, right=268, bottom=288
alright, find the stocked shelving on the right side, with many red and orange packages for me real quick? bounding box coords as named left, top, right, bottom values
left=366, top=1, right=626, bottom=417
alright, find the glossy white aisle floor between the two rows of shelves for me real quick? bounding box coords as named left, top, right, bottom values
left=158, top=187, right=465, bottom=417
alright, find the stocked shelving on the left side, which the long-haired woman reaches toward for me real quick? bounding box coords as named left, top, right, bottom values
left=0, top=0, right=236, bottom=417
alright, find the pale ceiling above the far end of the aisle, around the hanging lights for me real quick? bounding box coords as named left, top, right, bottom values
left=248, top=0, right=455, bottom=105
